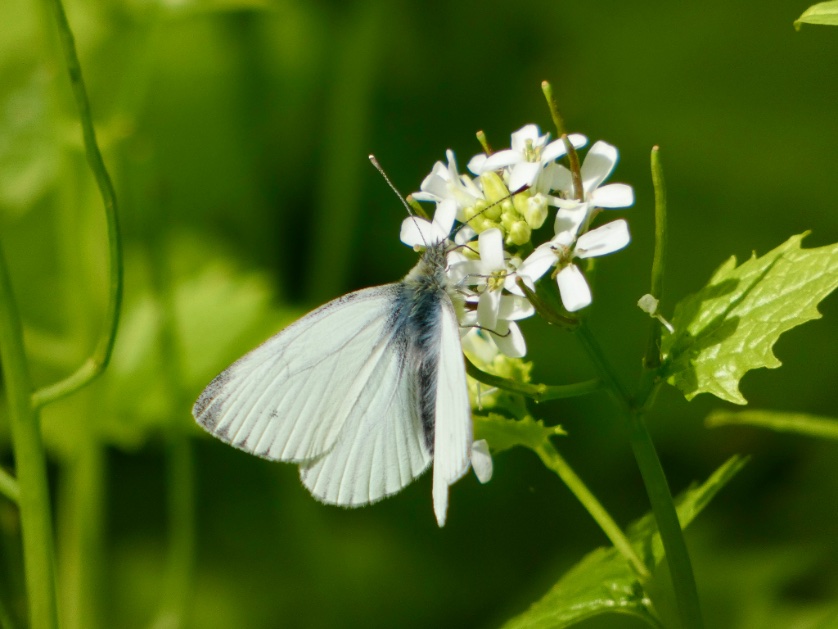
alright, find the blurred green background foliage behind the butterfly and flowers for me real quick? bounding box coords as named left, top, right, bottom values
left=0, top=0, right=838, bottom=629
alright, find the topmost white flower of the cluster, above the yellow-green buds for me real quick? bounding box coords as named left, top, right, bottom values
left=468, top=124, right=588, bottom=192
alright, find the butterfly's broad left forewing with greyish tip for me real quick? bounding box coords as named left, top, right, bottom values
left=192, top=284, right=427, bottom=466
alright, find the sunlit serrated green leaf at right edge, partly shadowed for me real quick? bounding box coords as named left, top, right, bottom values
left=662, top=234, right=838, bottom=404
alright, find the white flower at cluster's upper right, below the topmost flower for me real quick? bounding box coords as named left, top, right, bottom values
left=549, top=140, right=634, bottom=208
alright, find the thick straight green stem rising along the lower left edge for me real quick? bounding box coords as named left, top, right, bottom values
left=0, top=242, right=58, bottom=629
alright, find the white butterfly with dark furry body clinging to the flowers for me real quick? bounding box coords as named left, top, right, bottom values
left=192, top=212, right=480, bottom=526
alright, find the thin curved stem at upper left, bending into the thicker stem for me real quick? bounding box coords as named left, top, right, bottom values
left=33, top=0, right=123, bottom=407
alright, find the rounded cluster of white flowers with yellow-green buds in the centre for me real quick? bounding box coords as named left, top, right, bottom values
left=401, top=124, right=634, bottom=358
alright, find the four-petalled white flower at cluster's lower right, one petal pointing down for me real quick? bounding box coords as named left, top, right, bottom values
left=513, top=212, right=630, bottom=312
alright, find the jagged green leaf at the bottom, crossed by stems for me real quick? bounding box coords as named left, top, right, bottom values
left=504, top=456, right=746, bottom=629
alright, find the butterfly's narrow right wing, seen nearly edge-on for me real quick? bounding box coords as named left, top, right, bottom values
left=433, top=298, right=473, bottom=526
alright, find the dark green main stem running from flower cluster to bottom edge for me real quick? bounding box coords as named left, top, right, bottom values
left=576, top=324, right=704, bottom=629
